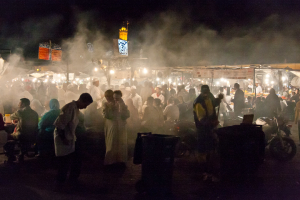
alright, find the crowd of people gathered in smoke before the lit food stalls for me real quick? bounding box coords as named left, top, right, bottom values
left=0, top=79, right=300, bottom=189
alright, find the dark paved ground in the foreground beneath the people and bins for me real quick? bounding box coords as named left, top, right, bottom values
left=0, top=126, right=300, bottom=200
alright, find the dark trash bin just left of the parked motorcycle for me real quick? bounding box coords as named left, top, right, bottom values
left=217, top=125, right=265, bottom=181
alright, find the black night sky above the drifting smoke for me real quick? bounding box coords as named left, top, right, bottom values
left=0, top=0, right=300, bottom=64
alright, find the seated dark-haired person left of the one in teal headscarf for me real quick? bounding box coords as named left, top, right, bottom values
left=4, top=98, right=39, bottom=161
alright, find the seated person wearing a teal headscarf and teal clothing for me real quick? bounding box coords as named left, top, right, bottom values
left=38, top=99, right=60, bottom=156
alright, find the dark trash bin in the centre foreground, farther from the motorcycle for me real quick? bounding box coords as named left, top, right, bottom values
left=136, top=134, right=179, bottom=195
